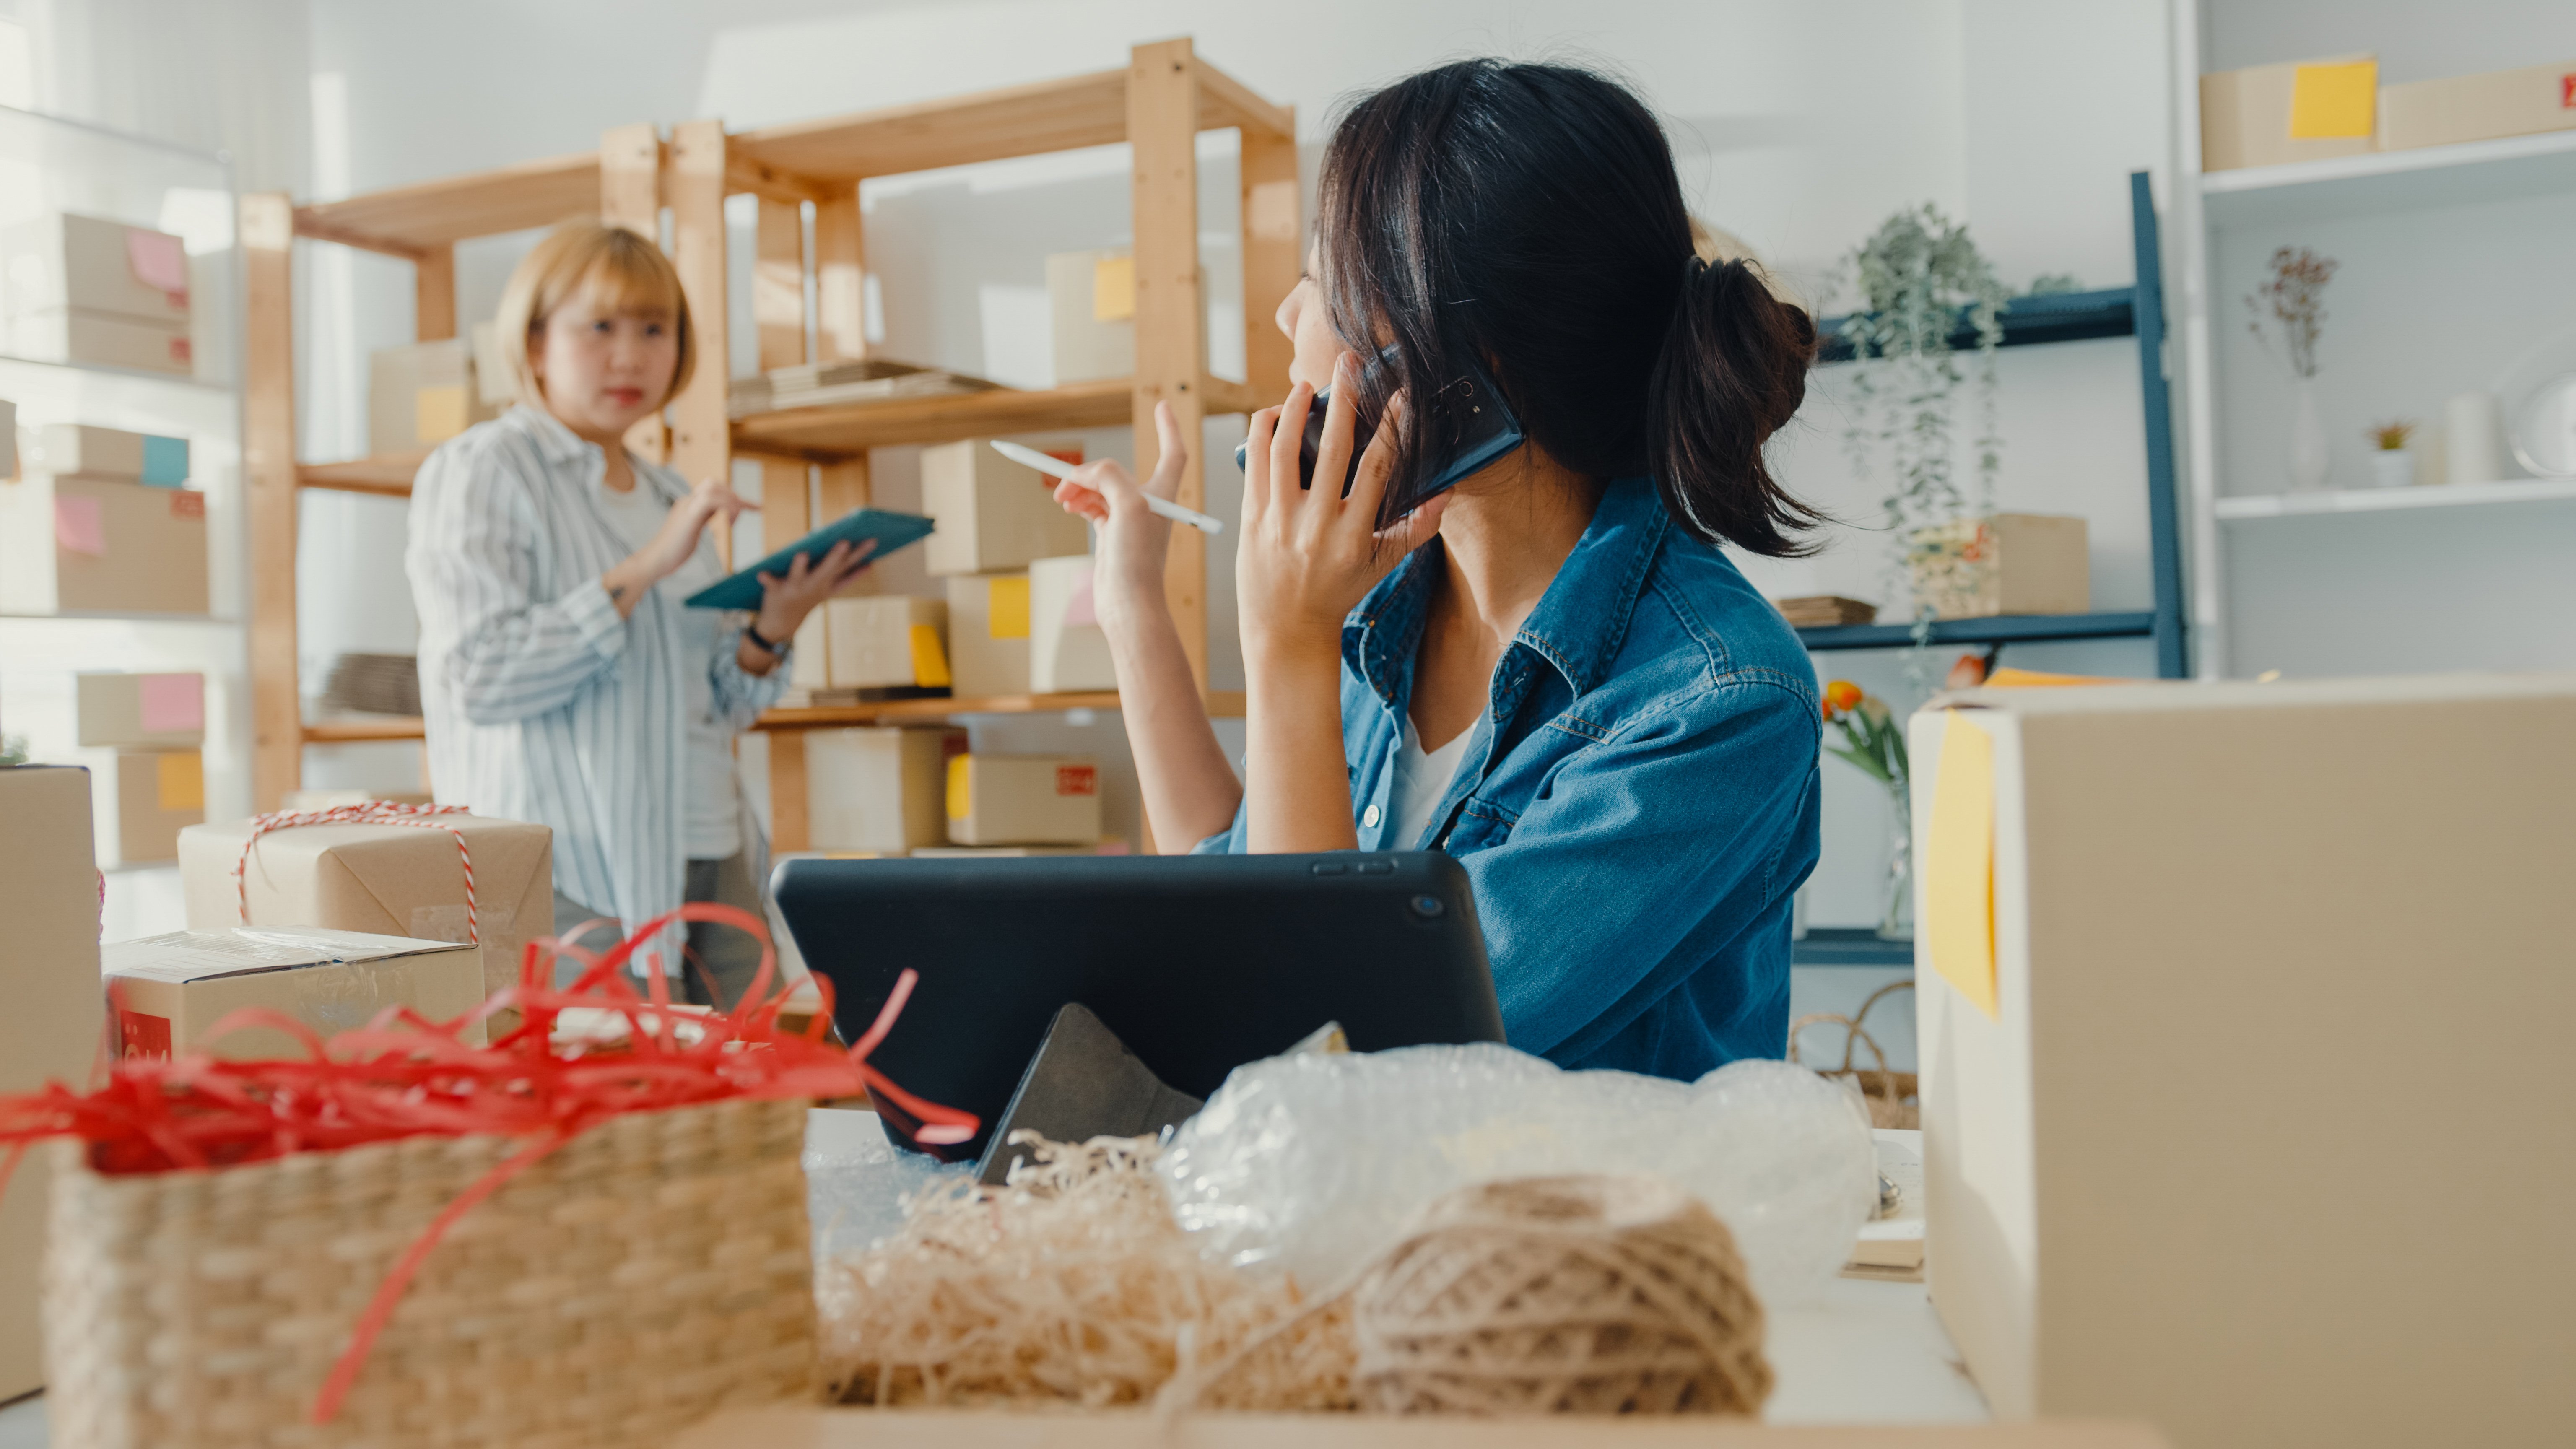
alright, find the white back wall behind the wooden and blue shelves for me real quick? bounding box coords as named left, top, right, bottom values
left=277, top=0, right=2169, bottom=926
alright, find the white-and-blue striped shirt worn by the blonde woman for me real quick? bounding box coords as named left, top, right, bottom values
left=405, top=408, right=788, bottom=949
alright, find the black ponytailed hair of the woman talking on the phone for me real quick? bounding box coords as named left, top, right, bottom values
left=1317, top=59, right=1821, bottom=557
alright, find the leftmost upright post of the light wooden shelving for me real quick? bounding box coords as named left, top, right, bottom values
left=239, top=191, right=304, bottom=812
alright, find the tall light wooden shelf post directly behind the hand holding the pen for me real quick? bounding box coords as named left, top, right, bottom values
left=1128, top=39, right=1205, bottom=691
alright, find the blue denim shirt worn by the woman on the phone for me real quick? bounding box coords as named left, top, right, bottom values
left=1198, top=477, right=1824, bottom=1080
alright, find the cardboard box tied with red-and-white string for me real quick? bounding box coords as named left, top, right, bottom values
left=178, top=815, right=554, bottom=1000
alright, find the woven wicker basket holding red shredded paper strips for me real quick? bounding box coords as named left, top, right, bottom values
left=44, top=1101, right=814, bottom=1449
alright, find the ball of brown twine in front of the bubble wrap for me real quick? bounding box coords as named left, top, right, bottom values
left=1353, top=1176, right=1772, bottom=1415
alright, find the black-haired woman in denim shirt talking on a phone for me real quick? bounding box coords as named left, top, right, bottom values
left=1056, top=59, right=1821, bottom=1078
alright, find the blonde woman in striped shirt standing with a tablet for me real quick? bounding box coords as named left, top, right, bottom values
left=405, top=222, right=863, bottom=1005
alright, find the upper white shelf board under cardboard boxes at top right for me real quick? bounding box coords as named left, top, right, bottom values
left=2200, top=132, right=2576, bottom=229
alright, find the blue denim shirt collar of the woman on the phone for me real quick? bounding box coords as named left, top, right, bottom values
left=1342, top=477, right=1672, bottom=724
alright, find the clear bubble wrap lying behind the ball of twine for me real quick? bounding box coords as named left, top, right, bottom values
left=1162, top=1044, right=1878, bottom=1305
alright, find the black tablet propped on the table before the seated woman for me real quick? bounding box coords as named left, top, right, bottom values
left=770, top=851, right=1502, bottom=1160
